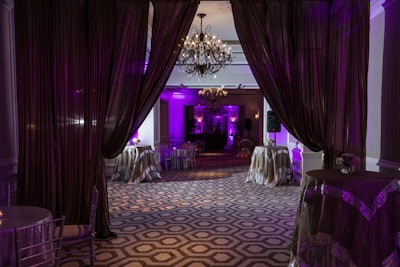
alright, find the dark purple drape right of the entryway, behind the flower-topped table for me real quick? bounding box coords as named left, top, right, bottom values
left=231, top=0, right=369, bottom=168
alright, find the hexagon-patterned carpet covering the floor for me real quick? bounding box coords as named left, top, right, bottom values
left=63, top=154, right=300, bottom=267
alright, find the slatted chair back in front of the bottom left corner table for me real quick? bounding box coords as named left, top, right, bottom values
left=15, top=216, right=65, bottom=267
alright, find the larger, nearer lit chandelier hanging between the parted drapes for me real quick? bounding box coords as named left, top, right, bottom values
left=177, top=13, right=232, bottom=77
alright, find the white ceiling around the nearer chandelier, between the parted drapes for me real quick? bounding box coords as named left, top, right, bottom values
left=166, top=1, right=258, bottom=89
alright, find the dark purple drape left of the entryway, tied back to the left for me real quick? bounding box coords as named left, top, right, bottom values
left=15, top=0, right=198, bottom=237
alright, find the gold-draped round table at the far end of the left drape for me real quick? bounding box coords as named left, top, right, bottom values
left=111, top=146, right=161, bottom=183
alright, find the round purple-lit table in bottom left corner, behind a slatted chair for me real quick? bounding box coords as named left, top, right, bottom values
left=0, top=206, right=53, bottom=266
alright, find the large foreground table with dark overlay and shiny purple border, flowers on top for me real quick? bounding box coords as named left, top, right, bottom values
left=289, top=169, right=400, bottom=267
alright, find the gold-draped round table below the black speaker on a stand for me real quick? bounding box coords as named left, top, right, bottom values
left=246, top=146, right=293, bottom=187
